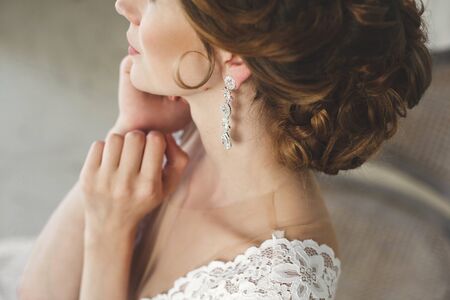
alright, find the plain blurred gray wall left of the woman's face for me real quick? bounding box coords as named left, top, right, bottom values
left=0, top=0, right=128, bottom=237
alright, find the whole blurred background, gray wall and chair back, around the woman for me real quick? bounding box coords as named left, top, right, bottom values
left=0, top=0, right=450, bottom=300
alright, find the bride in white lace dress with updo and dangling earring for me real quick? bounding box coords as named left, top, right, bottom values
left=18, top=0, right=431, bottom=300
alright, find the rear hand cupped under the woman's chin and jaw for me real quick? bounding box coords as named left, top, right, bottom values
left=110, top=55, right=192, bottom=134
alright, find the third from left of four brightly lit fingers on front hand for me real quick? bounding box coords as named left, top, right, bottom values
left=119, top=130, right=146, bottom=175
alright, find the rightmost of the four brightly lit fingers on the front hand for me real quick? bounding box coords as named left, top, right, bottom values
left=140, top=130, right=166, bottom=180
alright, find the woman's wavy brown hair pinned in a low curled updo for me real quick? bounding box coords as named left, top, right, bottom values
left=178, top=0, right=432, bottom=174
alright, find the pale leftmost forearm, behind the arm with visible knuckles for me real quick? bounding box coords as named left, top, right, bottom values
left=18, top=182, right=84, bottom=300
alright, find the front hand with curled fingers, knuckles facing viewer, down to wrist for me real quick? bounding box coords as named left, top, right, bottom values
left=79, top=130, right=189, bottom=236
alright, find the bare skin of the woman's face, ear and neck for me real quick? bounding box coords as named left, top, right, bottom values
left=116, top=0, right=298, bottom=206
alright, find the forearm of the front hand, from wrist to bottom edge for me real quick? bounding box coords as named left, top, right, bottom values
left=80, top=227, right=135, bottom=300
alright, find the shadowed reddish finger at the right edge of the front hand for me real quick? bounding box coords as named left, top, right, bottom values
left=162, top=133, right=189, bottom=195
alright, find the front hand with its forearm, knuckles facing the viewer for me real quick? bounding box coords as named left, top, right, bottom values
left=80, top=130, right=188, bottom=300
